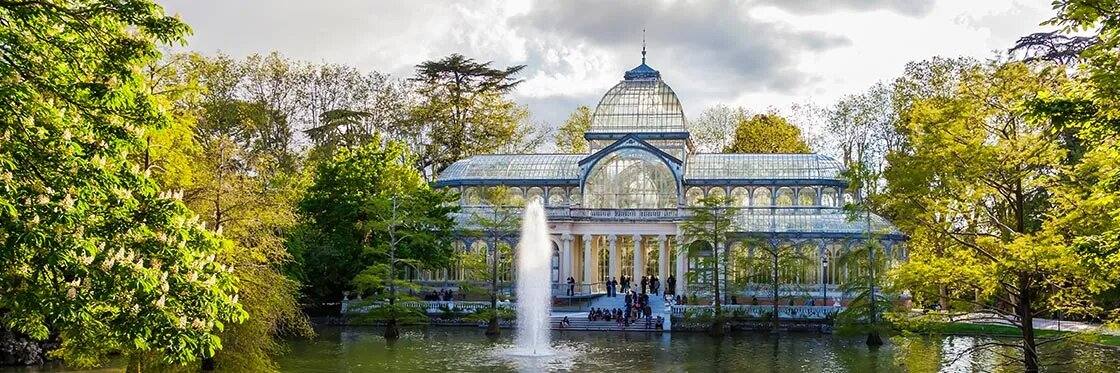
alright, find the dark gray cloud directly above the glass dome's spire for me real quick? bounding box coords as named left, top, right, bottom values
left=510, top=0, right=850, bottom=96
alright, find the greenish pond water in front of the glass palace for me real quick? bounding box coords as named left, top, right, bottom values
left=279, top=326, right=1120, bottom=372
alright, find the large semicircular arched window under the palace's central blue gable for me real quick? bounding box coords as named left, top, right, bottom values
left=584, top=148, right=678, bottom=208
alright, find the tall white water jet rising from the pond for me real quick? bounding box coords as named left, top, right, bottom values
left=514, top=198, right=552, bottom=356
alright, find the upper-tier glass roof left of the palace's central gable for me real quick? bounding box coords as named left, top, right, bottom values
left=436, top=155, right=587, bottom=183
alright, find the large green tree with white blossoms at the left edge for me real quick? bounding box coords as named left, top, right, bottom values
left=0, top=0, right=245, bottom=371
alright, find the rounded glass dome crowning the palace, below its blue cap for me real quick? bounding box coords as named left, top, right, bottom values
left=588, top=77, right=687, bottom=133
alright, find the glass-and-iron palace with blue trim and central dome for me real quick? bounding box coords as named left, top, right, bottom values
left=432, top=57, right=906, bottom=298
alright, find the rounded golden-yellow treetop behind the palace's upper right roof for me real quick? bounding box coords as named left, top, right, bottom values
left=724, top=114, right=812, bottom=153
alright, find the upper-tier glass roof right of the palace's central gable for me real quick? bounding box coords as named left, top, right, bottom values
left=684, top=153, right=841, bottom=180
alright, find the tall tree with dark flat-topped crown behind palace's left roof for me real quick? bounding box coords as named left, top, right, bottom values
left=410, top=54, right=525, bottom=176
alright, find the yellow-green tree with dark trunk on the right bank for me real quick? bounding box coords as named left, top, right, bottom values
left=881, top=63, right=1094, bottom=371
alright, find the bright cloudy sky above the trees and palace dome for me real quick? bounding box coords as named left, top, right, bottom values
left=161, top=0, right=1054, bottom=129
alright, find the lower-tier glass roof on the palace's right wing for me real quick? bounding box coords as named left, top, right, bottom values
left=735, top=208, right=902, bottom=234
